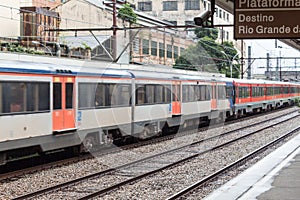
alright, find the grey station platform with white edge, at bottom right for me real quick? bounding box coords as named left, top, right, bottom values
left=205, top=134, right=300, bottom=200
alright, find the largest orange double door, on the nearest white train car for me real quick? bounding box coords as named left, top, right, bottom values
left=52, top=76, right=75, bottom=132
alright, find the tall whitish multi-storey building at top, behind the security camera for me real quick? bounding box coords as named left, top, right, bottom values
left=128, top=0, right=233, bottom=41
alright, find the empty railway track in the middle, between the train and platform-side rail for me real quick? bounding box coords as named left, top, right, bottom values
left=12, top=109, right=299, bottom=199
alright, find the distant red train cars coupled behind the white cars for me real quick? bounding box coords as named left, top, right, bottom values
left=233, top=79, right=299, bottom=117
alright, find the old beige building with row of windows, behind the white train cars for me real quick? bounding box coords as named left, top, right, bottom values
left=54, top=0, right=193, bottom=66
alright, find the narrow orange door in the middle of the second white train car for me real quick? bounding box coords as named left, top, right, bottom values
left=172, top=81, right=181, bottom=115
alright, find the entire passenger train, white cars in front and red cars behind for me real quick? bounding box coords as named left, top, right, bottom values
left=0, top=54, right=300, bottom=164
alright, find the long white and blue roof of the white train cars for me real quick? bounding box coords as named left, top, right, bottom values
left=0, top=53, right=224, bottom=80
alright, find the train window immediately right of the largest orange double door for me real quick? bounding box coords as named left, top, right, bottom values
left=78, top=83, right=96, bottom=109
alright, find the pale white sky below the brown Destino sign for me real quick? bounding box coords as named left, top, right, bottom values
left=244, top=39, right=300, bottom=74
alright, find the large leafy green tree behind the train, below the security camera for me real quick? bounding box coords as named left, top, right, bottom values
left=173, top=28, right=239, bottom=78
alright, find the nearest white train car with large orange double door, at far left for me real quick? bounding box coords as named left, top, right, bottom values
left=0, top=60, right=132, bottom=163
